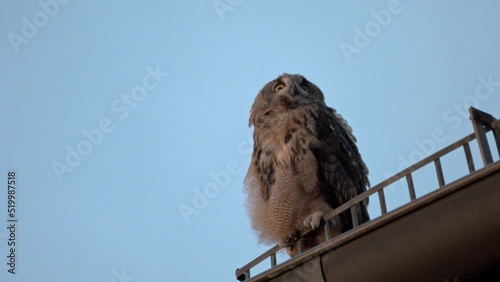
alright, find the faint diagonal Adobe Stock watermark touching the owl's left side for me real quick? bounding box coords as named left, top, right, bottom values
left=177, top=135, right=253, bottom=224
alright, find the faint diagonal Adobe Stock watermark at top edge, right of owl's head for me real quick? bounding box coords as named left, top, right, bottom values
left=339, top=0, right=403, bottom=63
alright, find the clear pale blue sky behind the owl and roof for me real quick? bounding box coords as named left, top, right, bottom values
left=0, top=0, right=500, bottom=282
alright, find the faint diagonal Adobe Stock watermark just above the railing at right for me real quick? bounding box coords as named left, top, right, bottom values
left=384, top=74, right=500, bottom=185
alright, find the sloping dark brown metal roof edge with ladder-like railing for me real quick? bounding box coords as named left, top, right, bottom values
left=236, top=107, right=500, bottom=281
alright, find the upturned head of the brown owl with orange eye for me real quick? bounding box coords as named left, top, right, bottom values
left=249, top=73, right=325, bottom=125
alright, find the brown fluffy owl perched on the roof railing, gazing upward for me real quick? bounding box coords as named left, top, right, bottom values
left=245, top=73, right=370, bottom=256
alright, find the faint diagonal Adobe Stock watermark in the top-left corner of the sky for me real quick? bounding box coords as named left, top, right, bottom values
left=7, top=0, right=70, bottom=54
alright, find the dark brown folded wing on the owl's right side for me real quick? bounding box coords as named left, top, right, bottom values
left=311, top=106, right=370, bottom=226
